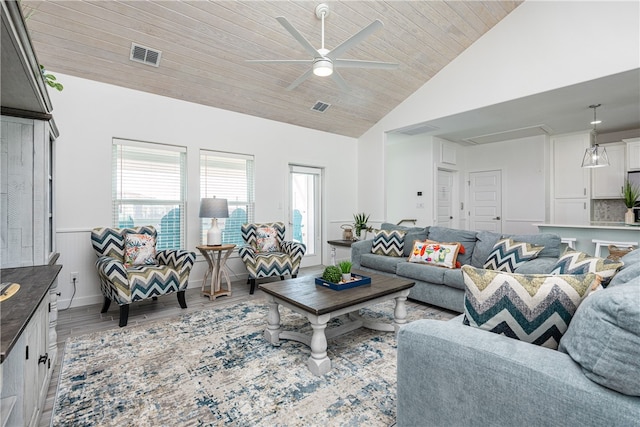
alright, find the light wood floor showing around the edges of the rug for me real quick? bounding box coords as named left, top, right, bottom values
left=39, top=267, right=457, bottom=427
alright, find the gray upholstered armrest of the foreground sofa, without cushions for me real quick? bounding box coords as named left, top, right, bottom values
left=397, top=319, right=640, bottom=427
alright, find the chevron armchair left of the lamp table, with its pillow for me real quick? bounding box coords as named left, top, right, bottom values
left=91, top=226, right=196, bottom=327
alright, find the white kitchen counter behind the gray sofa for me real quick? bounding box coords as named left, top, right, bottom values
left=534, top=221, right=640, bottom=257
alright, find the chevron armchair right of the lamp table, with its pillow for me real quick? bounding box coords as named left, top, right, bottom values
left=238, top=222, right=307, bottom=294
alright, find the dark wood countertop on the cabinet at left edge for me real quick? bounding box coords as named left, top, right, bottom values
left=0, top=265, right=62, bottom=363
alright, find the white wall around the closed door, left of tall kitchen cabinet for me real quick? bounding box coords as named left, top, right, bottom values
left=462, top=136, right=549, bottom=234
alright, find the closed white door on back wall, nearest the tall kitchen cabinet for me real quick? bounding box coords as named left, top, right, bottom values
left=469, top=170, right=502, bottom=233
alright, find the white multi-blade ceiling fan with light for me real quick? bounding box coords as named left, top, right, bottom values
left=247, top=3, right=398, bottom=91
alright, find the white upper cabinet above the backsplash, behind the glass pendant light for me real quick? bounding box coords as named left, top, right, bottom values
left=591, top=144, right=626, bottom=199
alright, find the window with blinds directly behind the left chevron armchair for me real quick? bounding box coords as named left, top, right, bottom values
left=113, top=139, right=186, bottom=250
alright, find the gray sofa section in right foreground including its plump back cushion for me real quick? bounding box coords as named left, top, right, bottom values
left=396, top=249, right=640, bottom=427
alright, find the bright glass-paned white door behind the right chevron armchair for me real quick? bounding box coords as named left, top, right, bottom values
left=287, top=165, right=322, bottom=267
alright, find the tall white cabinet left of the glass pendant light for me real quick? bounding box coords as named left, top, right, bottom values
left=551, top=131, right=592, bottom=225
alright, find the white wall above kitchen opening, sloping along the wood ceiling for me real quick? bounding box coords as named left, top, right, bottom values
left=358, top=0, right=640, bottom=224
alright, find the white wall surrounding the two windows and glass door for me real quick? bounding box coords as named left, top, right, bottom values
left=51, top=73, right=357, bottom=308
